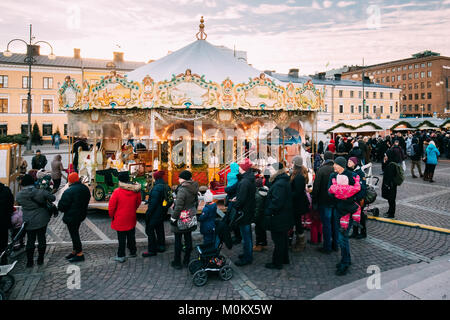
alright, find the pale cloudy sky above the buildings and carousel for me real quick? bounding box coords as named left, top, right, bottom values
left=0, top=0, right=450, bottom=75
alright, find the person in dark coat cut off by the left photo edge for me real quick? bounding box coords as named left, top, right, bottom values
left=0, top=183, right=14, bottom=265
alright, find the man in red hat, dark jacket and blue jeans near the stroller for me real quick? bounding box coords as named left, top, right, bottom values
left=233, top=159, right=256, bottom=266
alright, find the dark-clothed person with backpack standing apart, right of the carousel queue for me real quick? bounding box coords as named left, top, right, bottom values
left=381, top=150, right=402, bottom=219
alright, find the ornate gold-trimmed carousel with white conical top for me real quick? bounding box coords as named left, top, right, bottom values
left=59, top=17, right=323, bottom=209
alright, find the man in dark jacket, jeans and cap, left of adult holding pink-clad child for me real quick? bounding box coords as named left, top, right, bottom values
left=311, top=151, right=339, bottom=254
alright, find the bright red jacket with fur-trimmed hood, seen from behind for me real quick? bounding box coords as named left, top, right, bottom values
left=108, top=182, right=141, bottom=231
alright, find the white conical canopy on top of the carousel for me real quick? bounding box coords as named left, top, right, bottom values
left=127, top=40, right=278, bottom=83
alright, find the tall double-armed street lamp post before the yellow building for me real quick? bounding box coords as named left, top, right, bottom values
left=3, top=24, right=56, bottom=154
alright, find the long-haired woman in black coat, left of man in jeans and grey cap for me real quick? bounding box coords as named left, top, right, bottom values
left=290, top=157, right=309, bottom=252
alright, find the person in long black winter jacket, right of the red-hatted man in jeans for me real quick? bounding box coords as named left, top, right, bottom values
left=265, top=163, right=294, bottom=269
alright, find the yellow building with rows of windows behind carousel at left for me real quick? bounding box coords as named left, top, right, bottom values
left=0, top=49, right=145, bottom=140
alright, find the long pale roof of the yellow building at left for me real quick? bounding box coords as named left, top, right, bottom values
left=0, top=52, right=145, bottom=71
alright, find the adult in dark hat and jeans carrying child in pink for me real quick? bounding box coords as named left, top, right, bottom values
left=328, top=157, right=357, bottom=276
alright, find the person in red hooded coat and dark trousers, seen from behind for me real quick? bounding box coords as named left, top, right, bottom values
left=108, top=171, right=142, bottom=262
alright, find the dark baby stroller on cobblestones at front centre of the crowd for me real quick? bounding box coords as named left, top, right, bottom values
left=188, top=220, right=233, bottom=287
